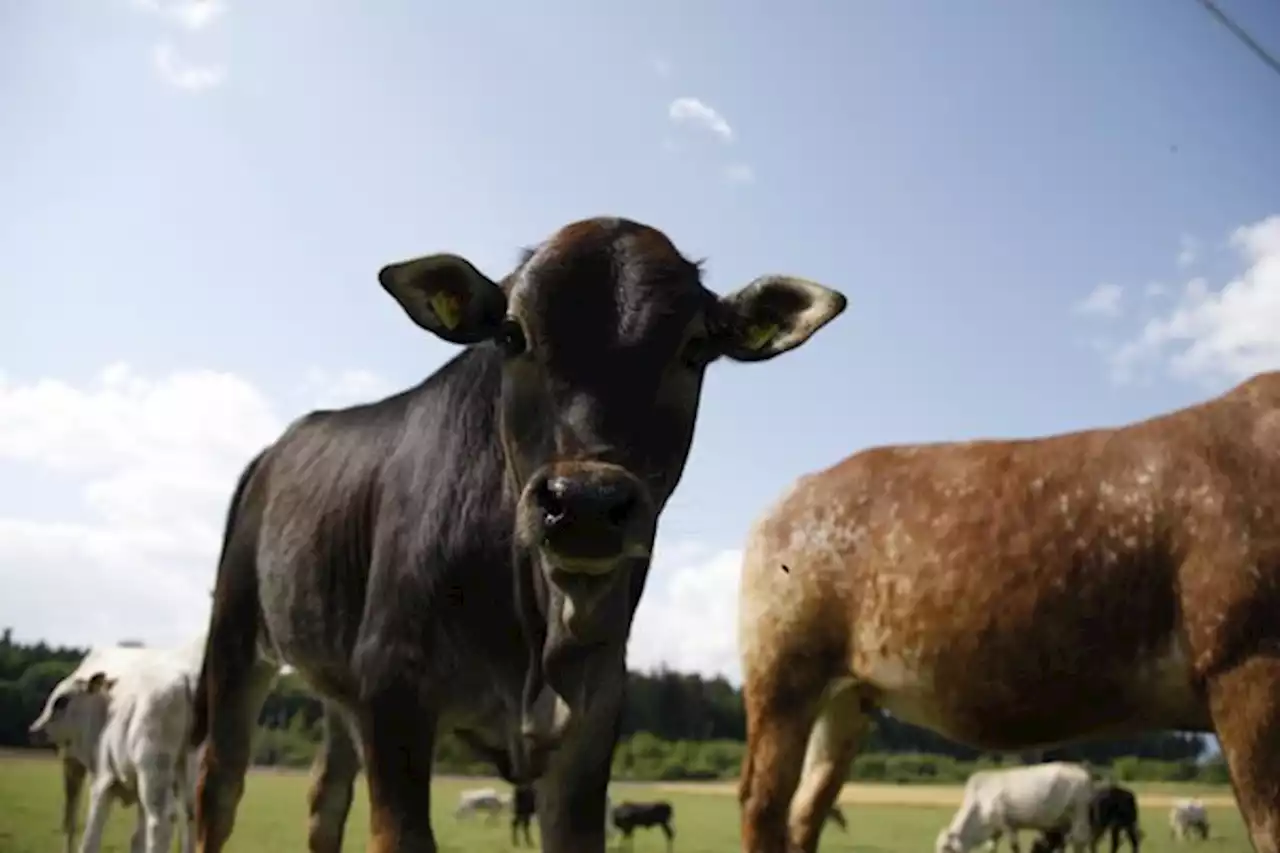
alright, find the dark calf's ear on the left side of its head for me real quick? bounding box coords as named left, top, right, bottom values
left=378, top=254, right=507, bottom=345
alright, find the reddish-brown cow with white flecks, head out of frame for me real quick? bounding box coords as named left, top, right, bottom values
left=740, top=373, right=1280, bottom=853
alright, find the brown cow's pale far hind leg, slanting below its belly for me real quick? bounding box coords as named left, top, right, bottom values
left=791, top=685, right=869, bottom=853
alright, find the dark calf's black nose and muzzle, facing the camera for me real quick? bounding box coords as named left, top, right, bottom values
left=532, top=470, right=641, bottom=561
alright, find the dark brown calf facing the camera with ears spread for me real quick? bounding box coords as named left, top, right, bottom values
left=195, top=218, right=845, bottom=853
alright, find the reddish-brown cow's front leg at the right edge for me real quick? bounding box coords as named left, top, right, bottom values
left=1208, top=656, right=1280, bottom=853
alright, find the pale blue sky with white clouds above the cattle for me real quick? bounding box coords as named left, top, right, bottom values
left=0, top=0, right=1280, bottom=674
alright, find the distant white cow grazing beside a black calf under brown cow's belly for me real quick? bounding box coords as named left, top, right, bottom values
left=934, top=762, right=1093, bottom=853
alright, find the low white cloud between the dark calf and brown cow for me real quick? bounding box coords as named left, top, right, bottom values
left=627, top=542, right=742, bottom=684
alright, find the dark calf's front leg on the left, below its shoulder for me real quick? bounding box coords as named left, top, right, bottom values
left=361, top=685, right=436, bottom=853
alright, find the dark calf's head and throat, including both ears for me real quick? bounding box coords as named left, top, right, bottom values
left=379, top=218, right=845, bottom=753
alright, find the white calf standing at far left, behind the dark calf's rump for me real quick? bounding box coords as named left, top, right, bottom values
left=31, top=640, right=204, bottom=853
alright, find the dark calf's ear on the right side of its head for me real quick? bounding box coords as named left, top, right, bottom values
left=716, top=275, right=849, bottom=361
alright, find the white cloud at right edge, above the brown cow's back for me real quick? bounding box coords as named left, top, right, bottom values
left=1111, top=215, right=1280, bottom=383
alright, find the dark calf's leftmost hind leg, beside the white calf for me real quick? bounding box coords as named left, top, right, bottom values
left=196, top=656, right=276, bottom=853
